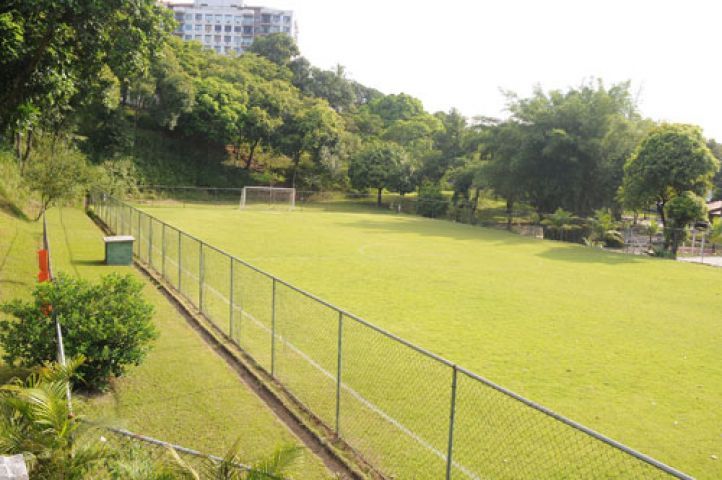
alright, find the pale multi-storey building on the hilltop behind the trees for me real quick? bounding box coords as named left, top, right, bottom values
left=161, top=0, right=297, bottom=54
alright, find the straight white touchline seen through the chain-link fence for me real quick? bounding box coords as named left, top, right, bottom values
left=162, top=253, right=481, bottom=480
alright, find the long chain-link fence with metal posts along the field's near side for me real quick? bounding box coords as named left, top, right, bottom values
left=91, top=193, right=690, bottom=479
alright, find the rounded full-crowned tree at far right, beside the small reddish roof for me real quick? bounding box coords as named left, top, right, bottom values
left=621, top=124, right=719, bottom=227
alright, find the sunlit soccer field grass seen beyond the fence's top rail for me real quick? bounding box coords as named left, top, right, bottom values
left=134, top=201, right=722, bottom=478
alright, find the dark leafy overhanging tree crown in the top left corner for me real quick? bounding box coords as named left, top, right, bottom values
left=0, top=0, right=174, bottom=131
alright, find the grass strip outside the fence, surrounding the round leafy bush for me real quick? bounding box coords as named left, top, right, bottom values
left=0, top=208, right=328, bottom=478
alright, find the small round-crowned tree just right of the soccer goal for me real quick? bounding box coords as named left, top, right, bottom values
left=348, top=142, right=404, bottom=207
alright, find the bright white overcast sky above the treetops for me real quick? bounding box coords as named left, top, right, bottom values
left=264, top=0, right=722, bottom=140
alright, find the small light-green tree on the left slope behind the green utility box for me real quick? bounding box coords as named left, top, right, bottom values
left=25, top=138, right=92, bottom=219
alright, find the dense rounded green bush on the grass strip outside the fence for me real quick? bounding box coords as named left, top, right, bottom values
left=0, top=274, right=157, bottom=390
